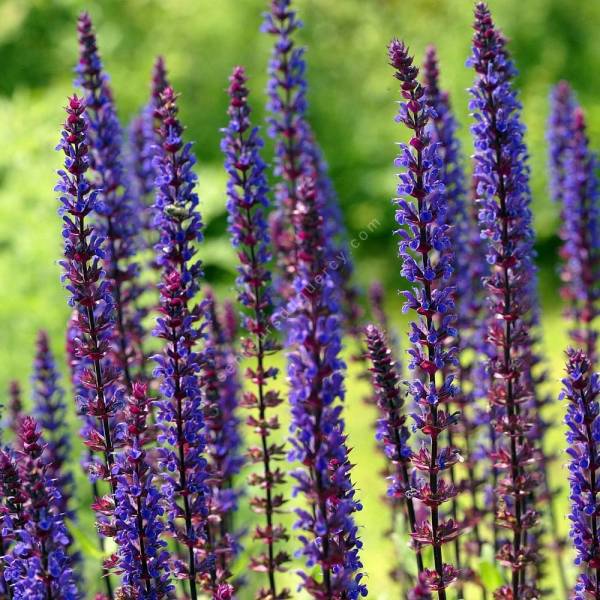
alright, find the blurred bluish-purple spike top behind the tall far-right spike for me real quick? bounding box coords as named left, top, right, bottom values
left=548, top=81, right=576, bottom=203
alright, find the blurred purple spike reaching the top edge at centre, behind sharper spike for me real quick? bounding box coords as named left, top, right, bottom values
left=262, top=0, right=307, bottom=298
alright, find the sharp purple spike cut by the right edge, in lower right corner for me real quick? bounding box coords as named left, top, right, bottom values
left=560, top=348, right=600, bottom=600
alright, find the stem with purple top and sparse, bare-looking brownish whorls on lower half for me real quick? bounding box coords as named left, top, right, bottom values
left=222, top=67, right=291, bottom=600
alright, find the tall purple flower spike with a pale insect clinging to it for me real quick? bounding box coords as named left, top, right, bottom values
left=154, top=87, right=214, bottom=600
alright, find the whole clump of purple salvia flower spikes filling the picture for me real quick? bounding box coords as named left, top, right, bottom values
left=0, top=0, right=600, bottom=600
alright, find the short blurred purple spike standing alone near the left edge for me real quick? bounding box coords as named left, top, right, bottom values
left=32, top=331, right=74, bottom=518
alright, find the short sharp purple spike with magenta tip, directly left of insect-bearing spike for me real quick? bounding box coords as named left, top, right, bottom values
left=113, top=382, right=174, bottom=600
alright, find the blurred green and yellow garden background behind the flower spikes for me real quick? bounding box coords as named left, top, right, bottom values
left=0, top=0, right=600, bottom=598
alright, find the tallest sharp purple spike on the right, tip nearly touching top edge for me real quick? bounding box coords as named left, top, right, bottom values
left=469, top=3, right=539, bottom=598
